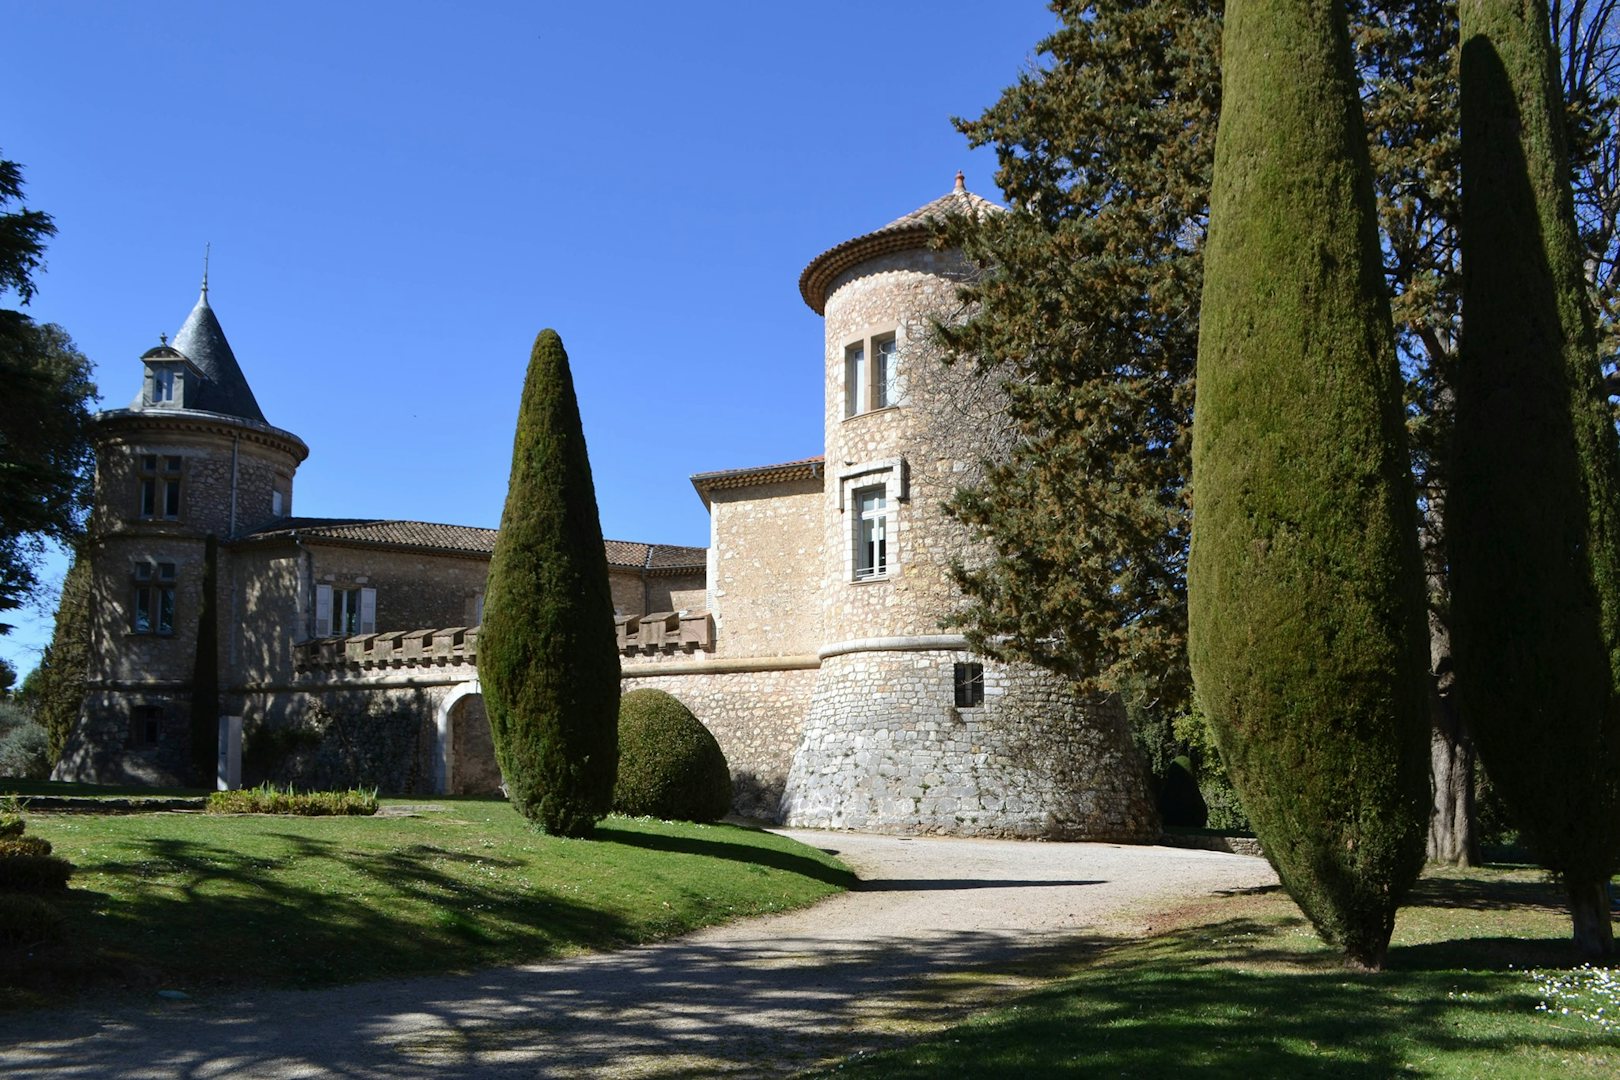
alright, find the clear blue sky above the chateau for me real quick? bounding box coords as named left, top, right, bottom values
left=0, top=0, right=1055, bottom=672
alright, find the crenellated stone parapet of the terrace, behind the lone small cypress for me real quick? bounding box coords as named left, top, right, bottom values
left=293, top=612, right=714, bottom=672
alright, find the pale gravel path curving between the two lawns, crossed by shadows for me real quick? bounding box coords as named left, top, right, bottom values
left=0, top=831, right=1277, bottom=1080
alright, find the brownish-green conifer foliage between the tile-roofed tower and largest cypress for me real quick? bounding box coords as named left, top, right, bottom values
left=940, top=0, right=1220, bottom=718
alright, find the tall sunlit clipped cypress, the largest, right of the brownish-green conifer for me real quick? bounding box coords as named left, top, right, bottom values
left=1189, top=0, right=1429, bottom=968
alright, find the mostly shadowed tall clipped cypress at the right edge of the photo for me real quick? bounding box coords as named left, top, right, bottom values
left=1450, top=0, right=1620, bottom=954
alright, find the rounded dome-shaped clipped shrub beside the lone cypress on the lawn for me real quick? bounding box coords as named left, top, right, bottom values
left=612, top=690, right=731, bottom=821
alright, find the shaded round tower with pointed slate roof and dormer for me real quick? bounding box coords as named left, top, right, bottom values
left=57, top=280, right=309, bottom=784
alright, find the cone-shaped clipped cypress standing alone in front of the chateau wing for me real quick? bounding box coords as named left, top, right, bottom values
left=478, top=330, right=619, bottom=837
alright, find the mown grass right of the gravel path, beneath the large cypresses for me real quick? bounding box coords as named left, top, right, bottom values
left=826, top=870, right=1620, bottom=1080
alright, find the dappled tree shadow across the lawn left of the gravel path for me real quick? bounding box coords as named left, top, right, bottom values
left=0, top=832, right=646, bottom=989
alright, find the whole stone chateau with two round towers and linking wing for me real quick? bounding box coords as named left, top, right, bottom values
left=57, top=176, right=1158, bottom=840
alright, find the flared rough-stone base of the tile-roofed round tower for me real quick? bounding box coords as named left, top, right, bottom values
left=781, top=648, right=1158, bottom=844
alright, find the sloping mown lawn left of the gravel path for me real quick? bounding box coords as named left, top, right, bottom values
left=0, top=800, right=854, bottom=1007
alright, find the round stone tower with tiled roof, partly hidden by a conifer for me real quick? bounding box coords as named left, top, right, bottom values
left=781, top=173, right=1158, bottom=840
